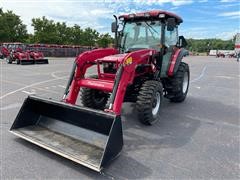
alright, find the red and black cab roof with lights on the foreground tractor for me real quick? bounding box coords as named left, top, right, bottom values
left=118, top=10, right=183, bottom=24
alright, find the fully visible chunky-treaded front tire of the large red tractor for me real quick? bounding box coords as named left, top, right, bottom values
left=136, top=80, right=163, bottom=125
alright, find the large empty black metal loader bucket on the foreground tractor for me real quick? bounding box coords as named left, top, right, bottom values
left=10, top=96, right=123, bottom=172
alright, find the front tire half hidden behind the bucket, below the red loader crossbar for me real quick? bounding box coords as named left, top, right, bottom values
left=81, top=75, right=109, bottom=110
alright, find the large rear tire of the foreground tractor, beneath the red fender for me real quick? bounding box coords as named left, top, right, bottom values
left=168, top=62, right=190, bottom=102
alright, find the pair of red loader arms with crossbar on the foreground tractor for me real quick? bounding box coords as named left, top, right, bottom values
left=65, top=48, right=156, bottom=115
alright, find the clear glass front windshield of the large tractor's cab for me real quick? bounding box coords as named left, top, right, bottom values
left=121, top=21, right=161, bottom=52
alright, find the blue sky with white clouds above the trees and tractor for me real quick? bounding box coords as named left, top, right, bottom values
left=0, top=0, right=240, bottom=40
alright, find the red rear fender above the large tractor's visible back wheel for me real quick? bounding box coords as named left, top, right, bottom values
left=168, top=48, right=188, bottom=76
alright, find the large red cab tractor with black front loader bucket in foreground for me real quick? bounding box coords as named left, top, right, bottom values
left=10, top=11, right=189, bottom=171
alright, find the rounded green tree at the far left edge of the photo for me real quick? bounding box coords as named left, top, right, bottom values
left=0, top=8, right=28, bottom=42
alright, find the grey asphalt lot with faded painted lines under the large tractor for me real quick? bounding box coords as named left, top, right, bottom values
left=0, top=57, right=240, bottom=179
